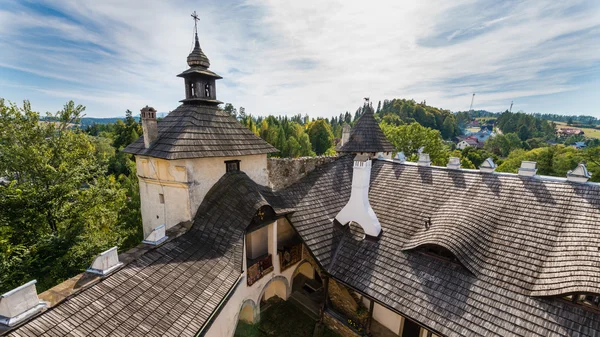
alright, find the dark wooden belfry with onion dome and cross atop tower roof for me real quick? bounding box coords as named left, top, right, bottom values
left=177, top=11, right=223, bottom=105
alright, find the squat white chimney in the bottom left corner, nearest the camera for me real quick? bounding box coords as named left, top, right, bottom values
left=0, top=280, right=46, bottom=326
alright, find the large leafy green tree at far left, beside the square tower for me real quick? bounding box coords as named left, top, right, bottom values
left=0, top=99, right=142, bottom=292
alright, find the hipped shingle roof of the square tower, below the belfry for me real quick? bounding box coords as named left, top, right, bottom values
left=123, top=104, right=277, bottom=159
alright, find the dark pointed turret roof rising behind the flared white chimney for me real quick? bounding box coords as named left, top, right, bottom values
left=338, top=105, right=396, bottom=153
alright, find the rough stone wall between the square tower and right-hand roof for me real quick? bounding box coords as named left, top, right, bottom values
left=267, top=156, right=338, bottom=190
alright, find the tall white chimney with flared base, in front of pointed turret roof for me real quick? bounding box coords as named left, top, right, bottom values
left=335, top=155, right=381, bottom=237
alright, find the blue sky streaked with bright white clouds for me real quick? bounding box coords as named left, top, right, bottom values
left=0, top=0, right=600, bottom=117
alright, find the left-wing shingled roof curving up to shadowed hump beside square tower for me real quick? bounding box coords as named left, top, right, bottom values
left=4, top=172, right=278, bottom=336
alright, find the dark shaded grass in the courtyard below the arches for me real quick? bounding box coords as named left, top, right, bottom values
left=234, top=297, right=340, bottom=337
